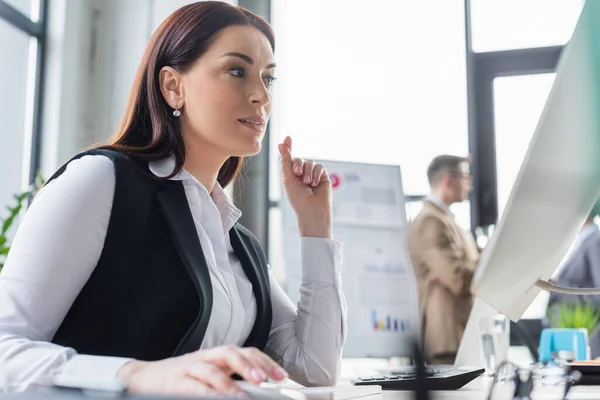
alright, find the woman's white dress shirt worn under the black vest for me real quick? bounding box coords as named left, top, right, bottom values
left=0, top=155, right=346, bottom=390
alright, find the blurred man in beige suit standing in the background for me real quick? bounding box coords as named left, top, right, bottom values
left=408, top=155, right=479, bottom=364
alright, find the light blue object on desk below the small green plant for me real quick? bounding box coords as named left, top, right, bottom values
left=539, top=328, right=590, bottom=362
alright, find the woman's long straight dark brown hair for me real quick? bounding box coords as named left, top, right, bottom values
left=99, top=1, right=275, bottom=187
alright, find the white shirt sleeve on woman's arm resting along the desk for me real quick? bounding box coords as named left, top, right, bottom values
left=0, top=156, right=130, bottom=391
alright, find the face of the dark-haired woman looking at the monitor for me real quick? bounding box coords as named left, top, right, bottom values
left=167, top=26, right=275, bottom=157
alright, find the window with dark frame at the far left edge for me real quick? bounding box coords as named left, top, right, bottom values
left=0, top=0, right=45, bottom=236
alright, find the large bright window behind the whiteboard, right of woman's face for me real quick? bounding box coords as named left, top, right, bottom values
left=269, top=0, right=470, bottom=265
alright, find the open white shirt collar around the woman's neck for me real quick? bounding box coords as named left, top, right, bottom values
left=148, top=156, right=242, bottom=233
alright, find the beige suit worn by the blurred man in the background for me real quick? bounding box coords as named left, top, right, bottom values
left=408, top=200, right=479, bottom=359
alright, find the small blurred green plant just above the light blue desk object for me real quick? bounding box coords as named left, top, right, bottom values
left=548, top=302, right=600, bottom=337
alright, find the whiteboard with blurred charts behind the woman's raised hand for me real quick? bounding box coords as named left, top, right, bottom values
left=282, top=160, right=420, bottom=358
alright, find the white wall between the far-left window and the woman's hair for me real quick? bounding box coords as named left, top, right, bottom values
left=42, top=0, right=237, bottom=176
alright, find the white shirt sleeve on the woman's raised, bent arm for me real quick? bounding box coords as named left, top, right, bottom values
left=266, top=237, right=347, bottom=386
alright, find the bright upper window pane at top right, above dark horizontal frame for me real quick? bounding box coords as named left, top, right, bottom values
left=470, top=0, right=584, bottom=52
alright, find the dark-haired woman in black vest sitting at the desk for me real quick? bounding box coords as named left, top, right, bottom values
left=0, top=2, right=345, bottom=395
